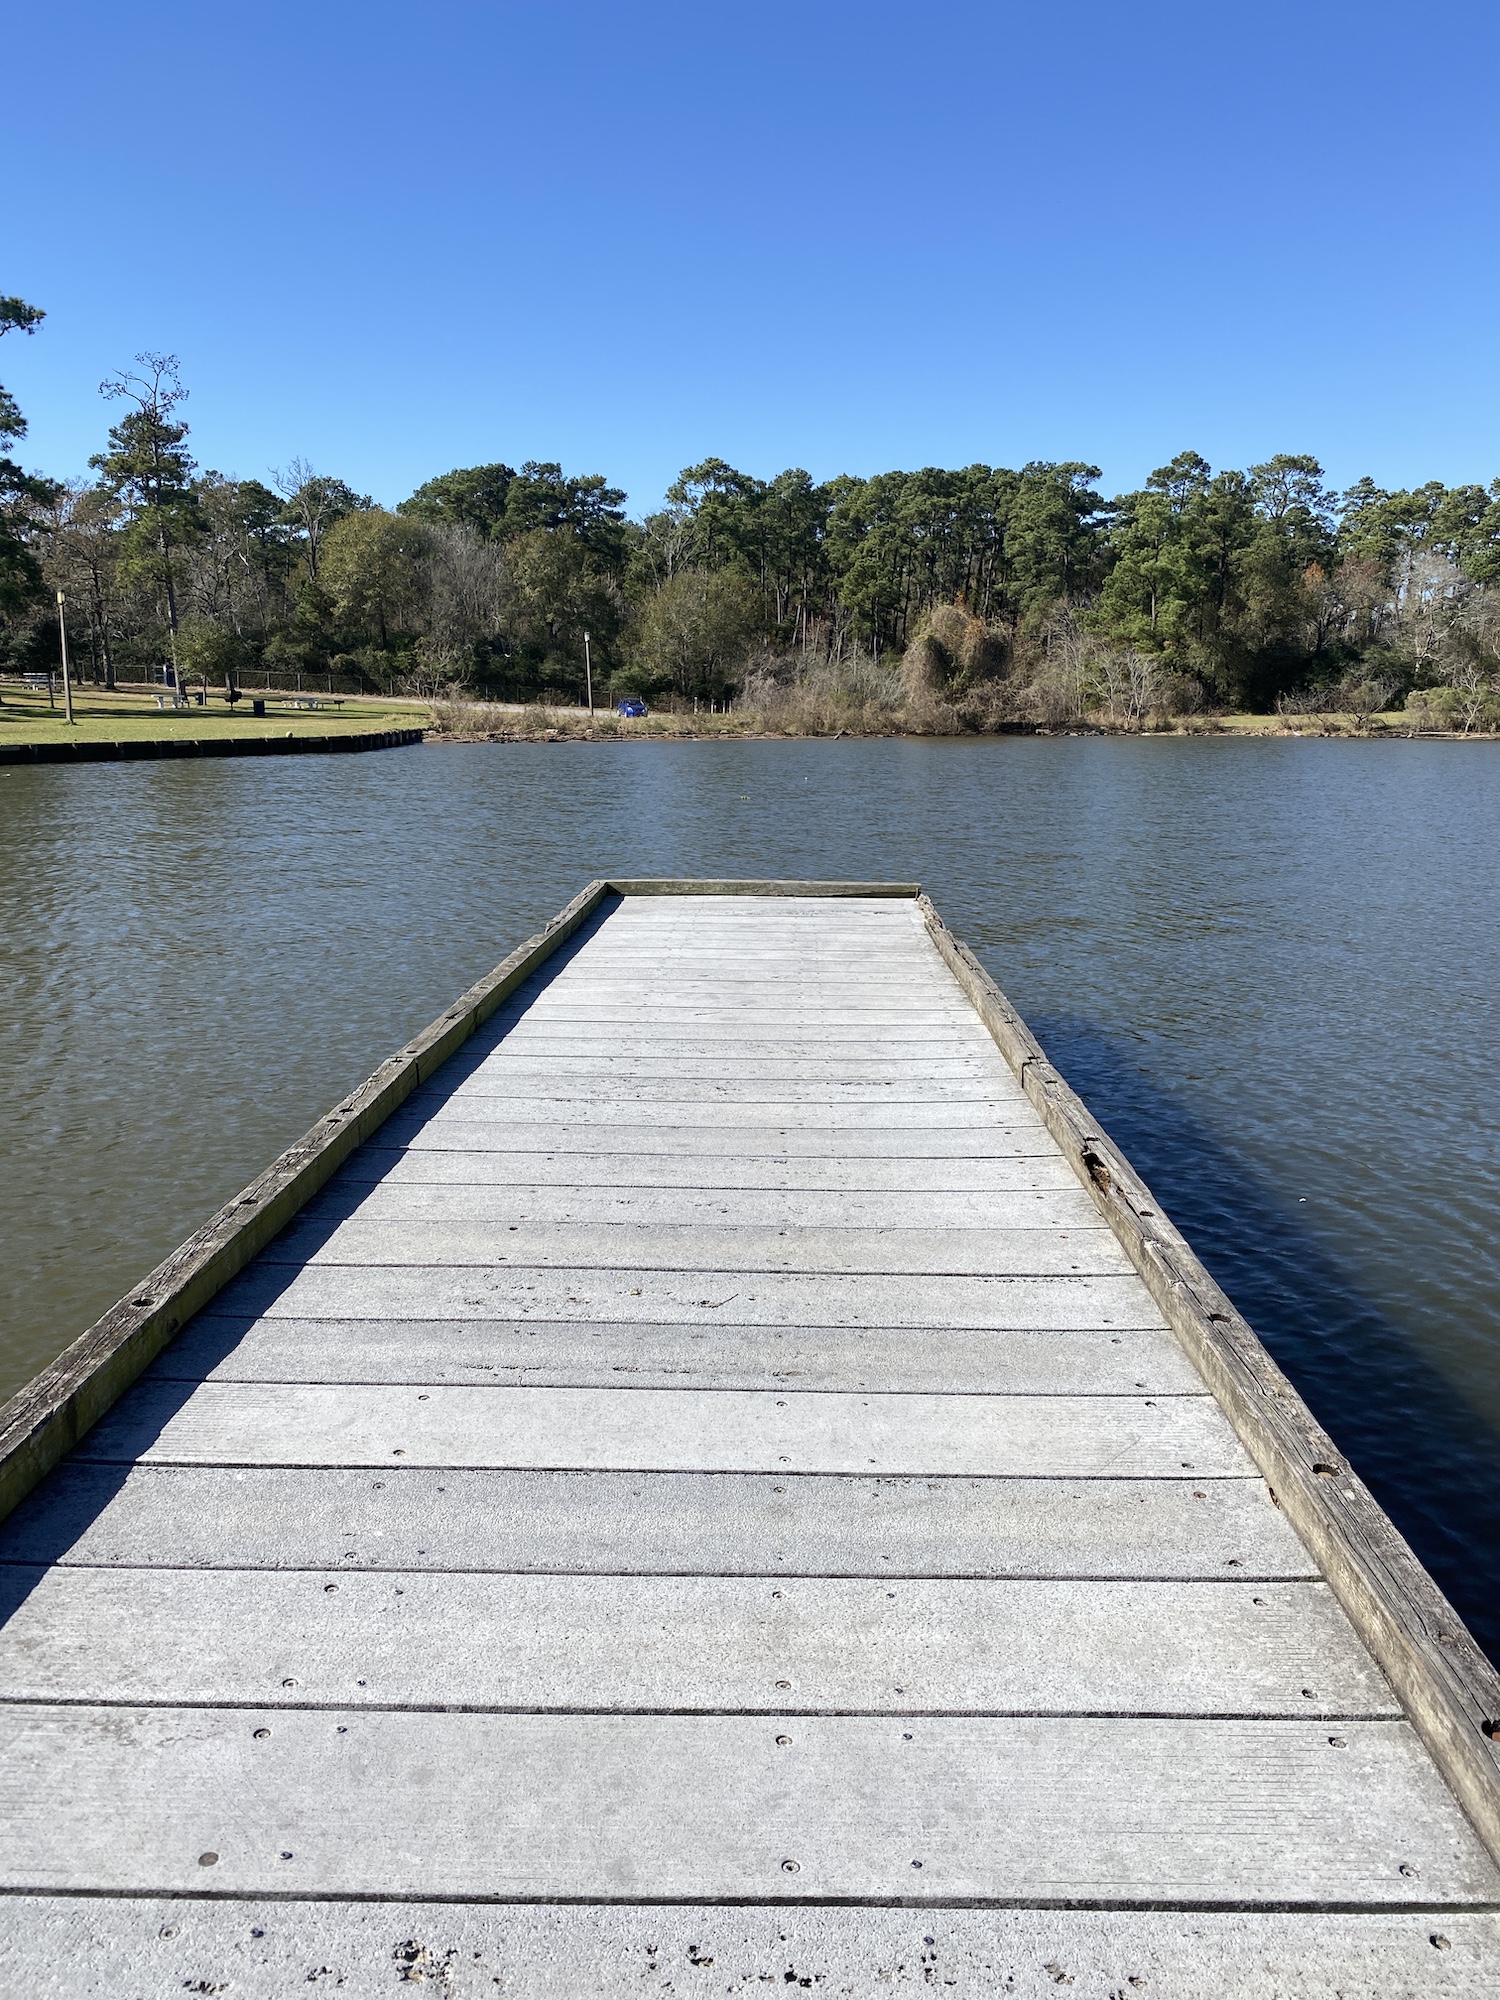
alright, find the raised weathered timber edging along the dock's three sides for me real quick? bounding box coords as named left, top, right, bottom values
left=0, top=878, right=1500, bottom=1860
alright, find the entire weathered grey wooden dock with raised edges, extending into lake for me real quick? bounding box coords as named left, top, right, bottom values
left=0, top=882, right=1500, bottom=2000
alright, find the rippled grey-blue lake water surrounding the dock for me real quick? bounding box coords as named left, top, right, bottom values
left=0, top=738, right=1500, bottom=1658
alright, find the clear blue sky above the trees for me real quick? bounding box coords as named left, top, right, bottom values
left=0, top=0, right=1500, bottom=512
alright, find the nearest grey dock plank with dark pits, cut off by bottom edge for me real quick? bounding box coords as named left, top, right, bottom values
left=0, top=1896, right=1500, bottom=2000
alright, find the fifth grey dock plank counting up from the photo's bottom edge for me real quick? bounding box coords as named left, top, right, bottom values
left=78, top=1382, right=1254, bottom=1480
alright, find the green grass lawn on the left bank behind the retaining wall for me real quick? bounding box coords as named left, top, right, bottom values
left=0, top=682, right=428, bottom=744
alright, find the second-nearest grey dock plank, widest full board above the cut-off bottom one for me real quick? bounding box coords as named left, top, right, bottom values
left=0, top=1702, right=1496, bottom=1910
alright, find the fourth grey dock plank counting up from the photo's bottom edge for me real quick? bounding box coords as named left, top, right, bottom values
left=4, top=1460, right=1316, bottom=1582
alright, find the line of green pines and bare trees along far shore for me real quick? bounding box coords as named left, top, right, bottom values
left=0, top=298, right=1500, bottom=726
